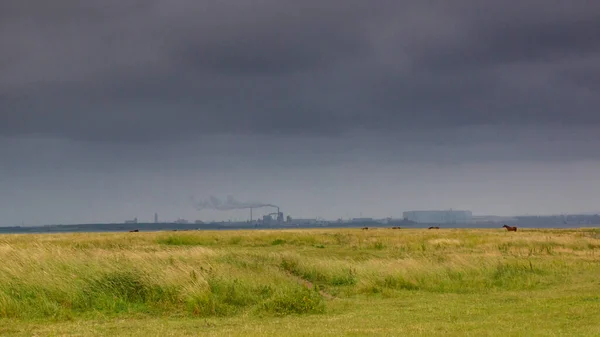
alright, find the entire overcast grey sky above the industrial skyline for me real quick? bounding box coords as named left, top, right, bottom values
left=0, top=0, right=600, bottom=225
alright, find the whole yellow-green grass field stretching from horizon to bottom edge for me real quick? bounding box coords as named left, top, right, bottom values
left=0, top=228, right=600, bottom=337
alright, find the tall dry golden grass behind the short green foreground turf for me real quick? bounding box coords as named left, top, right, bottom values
left=0, top=229, right=600, bottom=320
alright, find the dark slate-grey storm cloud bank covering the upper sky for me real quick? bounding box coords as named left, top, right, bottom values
left=0, top=0, right=600, bottom=140
